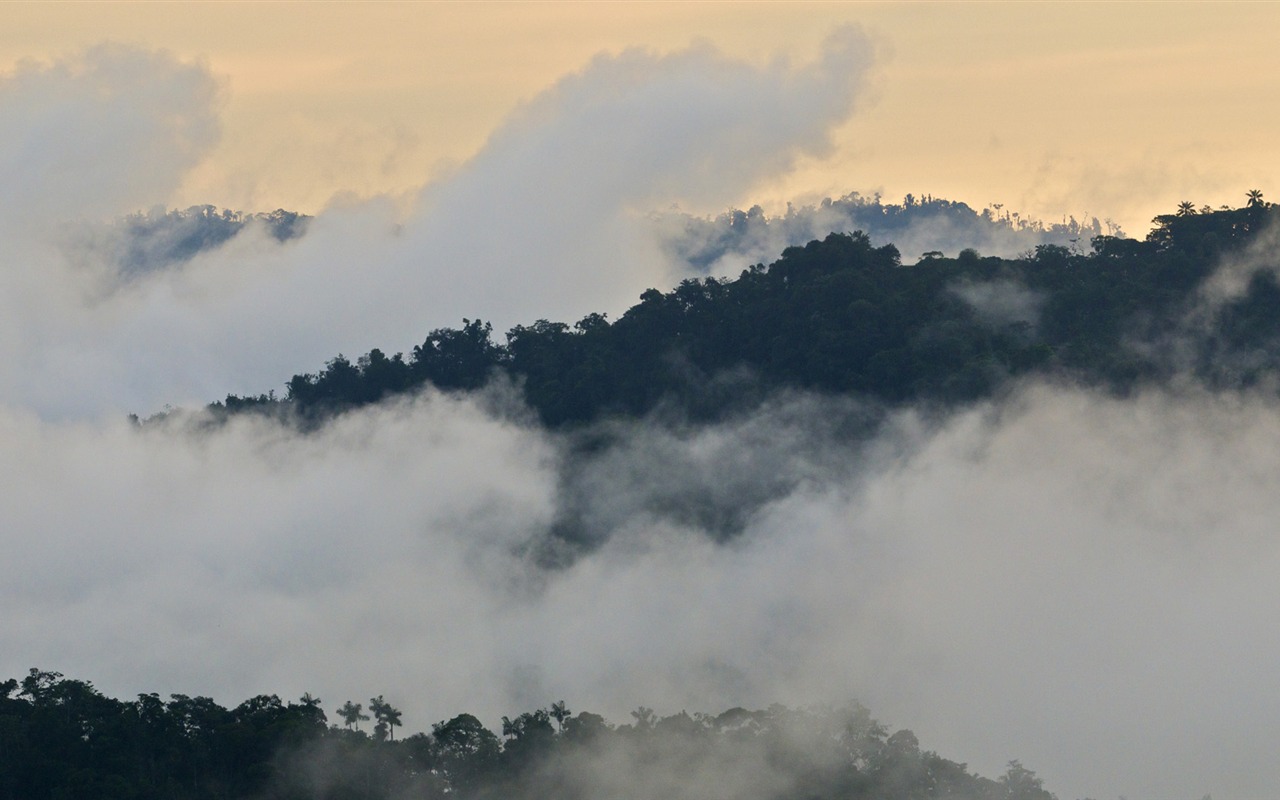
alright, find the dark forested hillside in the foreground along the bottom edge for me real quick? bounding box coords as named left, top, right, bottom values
left=0, top=669, right=1053, bottom=800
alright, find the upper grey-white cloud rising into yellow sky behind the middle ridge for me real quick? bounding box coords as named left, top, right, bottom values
left=0, top=28, right=872, bottom=417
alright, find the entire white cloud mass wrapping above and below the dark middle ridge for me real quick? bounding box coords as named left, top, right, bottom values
left=0, top=31, right=1280, bottom=800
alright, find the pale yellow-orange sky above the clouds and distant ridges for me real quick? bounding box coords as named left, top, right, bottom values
left=0, top=3, right=1280, bottom=234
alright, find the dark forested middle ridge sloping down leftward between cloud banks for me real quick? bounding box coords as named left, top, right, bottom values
left=204, top=196, right=1280, bottom=428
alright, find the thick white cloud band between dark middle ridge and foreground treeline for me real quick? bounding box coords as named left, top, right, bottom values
left=0, top=387, right=1280, bottom=797
